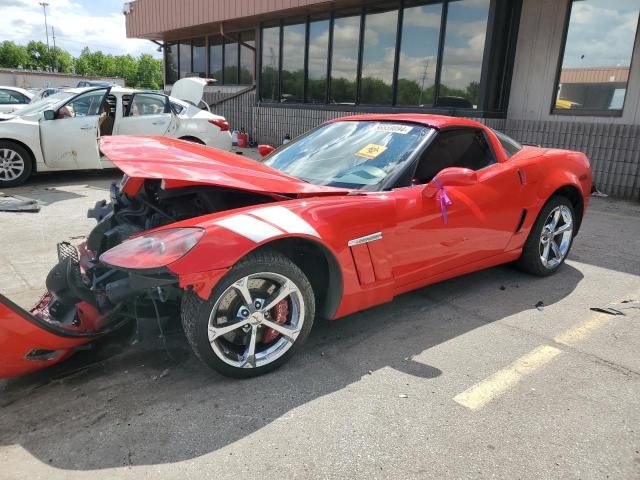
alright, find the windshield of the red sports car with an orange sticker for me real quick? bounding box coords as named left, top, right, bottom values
left=264, top=121, right=432, bottom=190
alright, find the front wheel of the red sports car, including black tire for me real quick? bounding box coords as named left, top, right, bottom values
left=181, top=250, right=315, bottom=378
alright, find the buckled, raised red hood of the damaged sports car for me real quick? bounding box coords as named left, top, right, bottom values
left=100, top=135, right=348, bottom=196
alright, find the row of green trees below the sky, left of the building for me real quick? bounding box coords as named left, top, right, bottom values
left=0, top=41, right=162, bottom=90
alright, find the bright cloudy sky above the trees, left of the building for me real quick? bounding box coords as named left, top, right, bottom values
left=0, top=0, right=161, bottom=58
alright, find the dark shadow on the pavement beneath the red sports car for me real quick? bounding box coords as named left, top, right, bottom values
left=0, top=265, right=583, bottom=470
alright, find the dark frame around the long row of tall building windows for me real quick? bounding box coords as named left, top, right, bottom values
left=256, top=0, right=523, bottom=118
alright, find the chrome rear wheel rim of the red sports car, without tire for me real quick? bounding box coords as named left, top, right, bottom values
left=539, top=205, right=573, bottom=270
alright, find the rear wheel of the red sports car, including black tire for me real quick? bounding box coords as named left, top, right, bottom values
left=516, top=195, right=576, bottom=277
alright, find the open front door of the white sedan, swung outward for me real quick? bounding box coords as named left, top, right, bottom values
left=40, top=88, right=109, bottom=170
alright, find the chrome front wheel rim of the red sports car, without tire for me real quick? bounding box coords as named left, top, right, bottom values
left=208, top=272, right=305, bottom=368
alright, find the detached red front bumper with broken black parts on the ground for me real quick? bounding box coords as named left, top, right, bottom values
left=0, top=236, right=177, bottom=378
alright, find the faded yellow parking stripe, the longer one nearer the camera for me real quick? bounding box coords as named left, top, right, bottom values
left=453, top=345, right=561, bottom=410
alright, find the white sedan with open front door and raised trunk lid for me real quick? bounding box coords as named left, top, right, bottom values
left=0, top=78, right=231, bottom=189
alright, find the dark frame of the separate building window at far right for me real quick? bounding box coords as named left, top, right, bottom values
left=549, top=0, right=640, bottom=118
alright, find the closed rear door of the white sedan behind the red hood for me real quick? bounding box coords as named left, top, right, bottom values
left=116, top=92, right=175, bottom=136
